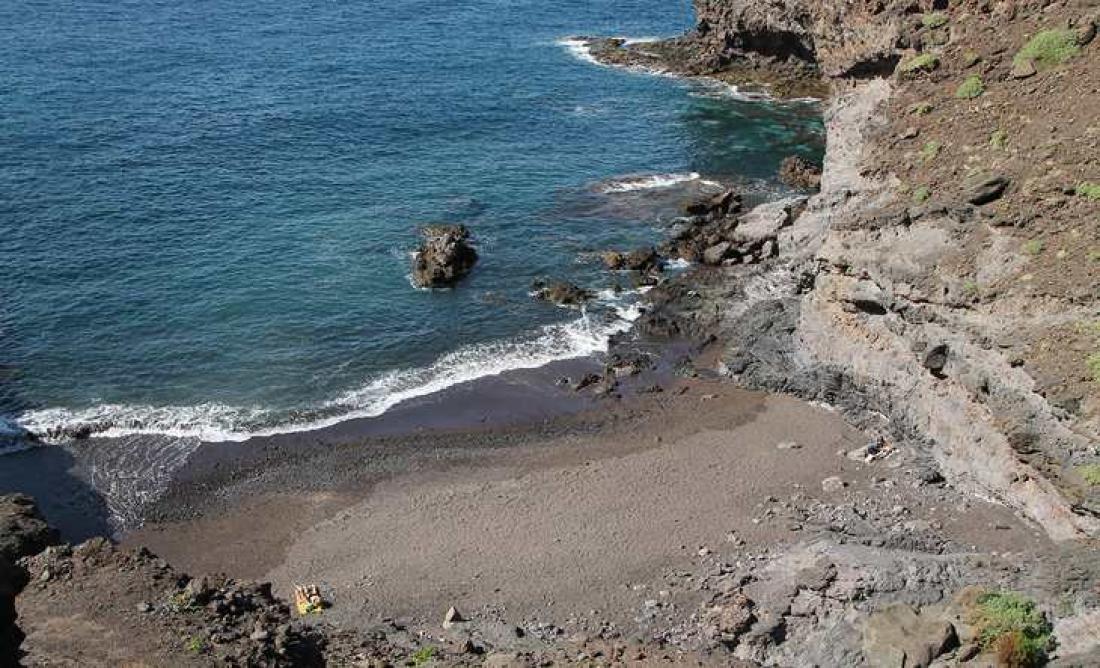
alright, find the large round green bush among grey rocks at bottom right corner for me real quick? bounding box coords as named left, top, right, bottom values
left=970, top=591, right=1053, bottom=667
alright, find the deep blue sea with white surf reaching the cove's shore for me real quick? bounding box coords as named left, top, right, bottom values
left=0, top=0, right=822, bottom=444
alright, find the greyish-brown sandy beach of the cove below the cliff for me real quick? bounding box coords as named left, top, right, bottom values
left=124, top=380, right=1044, bottom=627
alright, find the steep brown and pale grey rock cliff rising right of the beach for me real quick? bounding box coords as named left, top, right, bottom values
left=693, top=0, right=1100, bottom=539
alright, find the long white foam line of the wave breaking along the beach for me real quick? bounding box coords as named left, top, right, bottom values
left=8, top=300, right=641, bottom=444
